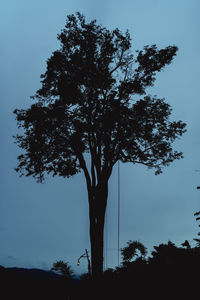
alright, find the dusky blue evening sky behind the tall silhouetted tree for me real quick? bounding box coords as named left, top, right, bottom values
left=0, top=0, right=200, bottom=273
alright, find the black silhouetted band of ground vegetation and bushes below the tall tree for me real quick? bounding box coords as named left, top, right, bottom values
left=0, top=236, right=200, bottom=300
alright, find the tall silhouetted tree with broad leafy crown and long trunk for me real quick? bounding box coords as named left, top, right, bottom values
left=14, top=13, right=185, bottom=277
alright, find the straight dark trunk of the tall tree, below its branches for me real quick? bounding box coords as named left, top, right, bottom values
left=89, top=182, right=108, bottom=279
